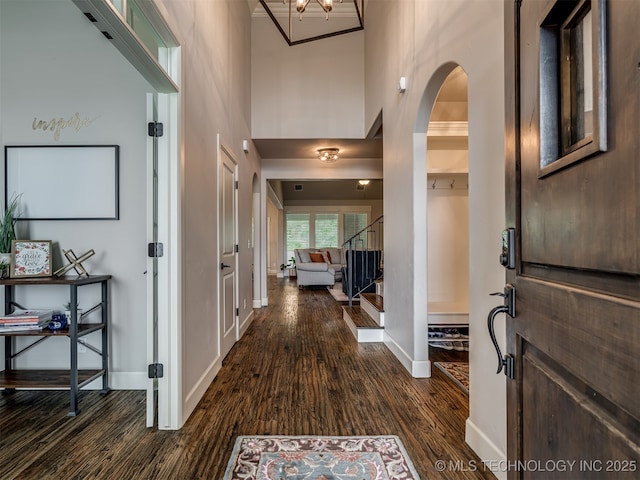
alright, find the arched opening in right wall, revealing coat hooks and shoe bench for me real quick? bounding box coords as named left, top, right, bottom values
left=426, top=66, right=469, bottom=370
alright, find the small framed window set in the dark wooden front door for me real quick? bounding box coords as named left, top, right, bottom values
left=539, top=0, right=607, bottom=177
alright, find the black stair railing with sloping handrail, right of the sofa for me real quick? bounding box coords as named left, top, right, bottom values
left=342, top=215, right=384, bottom=307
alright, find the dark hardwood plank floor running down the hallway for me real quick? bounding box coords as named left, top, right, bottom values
left=0, top=278, right=494, bottom=480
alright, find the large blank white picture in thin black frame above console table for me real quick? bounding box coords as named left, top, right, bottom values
left=5, top=145, right=120, bottom=220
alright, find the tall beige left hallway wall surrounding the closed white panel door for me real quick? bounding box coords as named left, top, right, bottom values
left=157, top=0, right=266, bottom=420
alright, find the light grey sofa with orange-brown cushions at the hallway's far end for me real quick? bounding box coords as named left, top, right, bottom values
left=293, top=248, right=344, bottom=288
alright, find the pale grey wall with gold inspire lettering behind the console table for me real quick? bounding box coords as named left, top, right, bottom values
left=0, top=0, right=152, bottom=389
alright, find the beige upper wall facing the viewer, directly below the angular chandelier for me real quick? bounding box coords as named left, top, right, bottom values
left=251, top=16, right=364, bottom=138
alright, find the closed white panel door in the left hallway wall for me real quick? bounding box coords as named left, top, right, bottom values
left=218, top=144, right=238, bottom=358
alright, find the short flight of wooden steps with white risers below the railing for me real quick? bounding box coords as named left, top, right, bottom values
left=342, top=280, right=384, bottom=343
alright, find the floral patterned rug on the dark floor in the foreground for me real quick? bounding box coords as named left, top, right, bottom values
left=224, top=435, right=420, bottom=480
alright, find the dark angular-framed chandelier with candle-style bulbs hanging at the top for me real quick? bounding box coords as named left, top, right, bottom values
left=259, top=0, right=364, bottom=46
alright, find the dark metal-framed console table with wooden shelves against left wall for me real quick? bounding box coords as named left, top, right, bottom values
left=0, top=275, right=111, bottom=417
